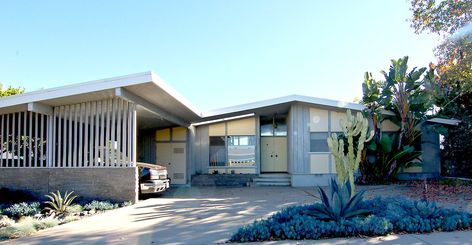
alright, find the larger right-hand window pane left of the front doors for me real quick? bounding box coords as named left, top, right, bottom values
left=228, top=135, right=256, bottom=166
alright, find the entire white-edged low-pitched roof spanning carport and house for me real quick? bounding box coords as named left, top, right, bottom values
left=0, top=71, right=376, bottom=123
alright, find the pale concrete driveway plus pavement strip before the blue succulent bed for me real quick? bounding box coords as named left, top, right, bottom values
left=3, top=187, right=472, bottom=245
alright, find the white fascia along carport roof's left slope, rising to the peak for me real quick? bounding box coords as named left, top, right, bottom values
left=0, top=72, right=152, bottom=108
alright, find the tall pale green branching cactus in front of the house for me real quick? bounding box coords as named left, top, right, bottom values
left=327, top=110, right=374, bottom=193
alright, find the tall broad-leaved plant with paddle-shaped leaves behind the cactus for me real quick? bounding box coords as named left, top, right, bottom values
left=360, top=57, right=433, bottom=183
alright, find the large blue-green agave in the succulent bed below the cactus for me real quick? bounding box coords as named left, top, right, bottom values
left=305, top=178, right=370, bottom=222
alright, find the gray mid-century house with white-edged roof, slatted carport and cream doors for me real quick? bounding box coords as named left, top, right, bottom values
left=0, top=72, right=448, bottom=200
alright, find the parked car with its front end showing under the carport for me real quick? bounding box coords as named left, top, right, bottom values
left=137, top=163, right=170, bottom=194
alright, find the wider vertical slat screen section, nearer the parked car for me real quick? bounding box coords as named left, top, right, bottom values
left=52, top=98, right=136, bottom=168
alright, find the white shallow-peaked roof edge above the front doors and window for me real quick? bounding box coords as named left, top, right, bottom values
left=203, top=95, right=365, bottom=118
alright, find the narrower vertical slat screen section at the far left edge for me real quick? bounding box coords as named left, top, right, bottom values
left=0, top=111, right=50, bottom=168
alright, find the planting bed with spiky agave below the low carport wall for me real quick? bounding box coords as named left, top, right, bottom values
left=0, top=188, right=131, bottom=241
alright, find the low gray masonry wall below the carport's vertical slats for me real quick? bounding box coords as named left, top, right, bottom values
left=0, top=167, right=138, bottom=202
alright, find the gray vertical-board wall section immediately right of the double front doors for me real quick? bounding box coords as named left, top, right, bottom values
left=287, top=104, right=310, bottom=174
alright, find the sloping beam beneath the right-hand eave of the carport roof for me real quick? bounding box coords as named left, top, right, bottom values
left=115, top=88, right=190, bottom=127
